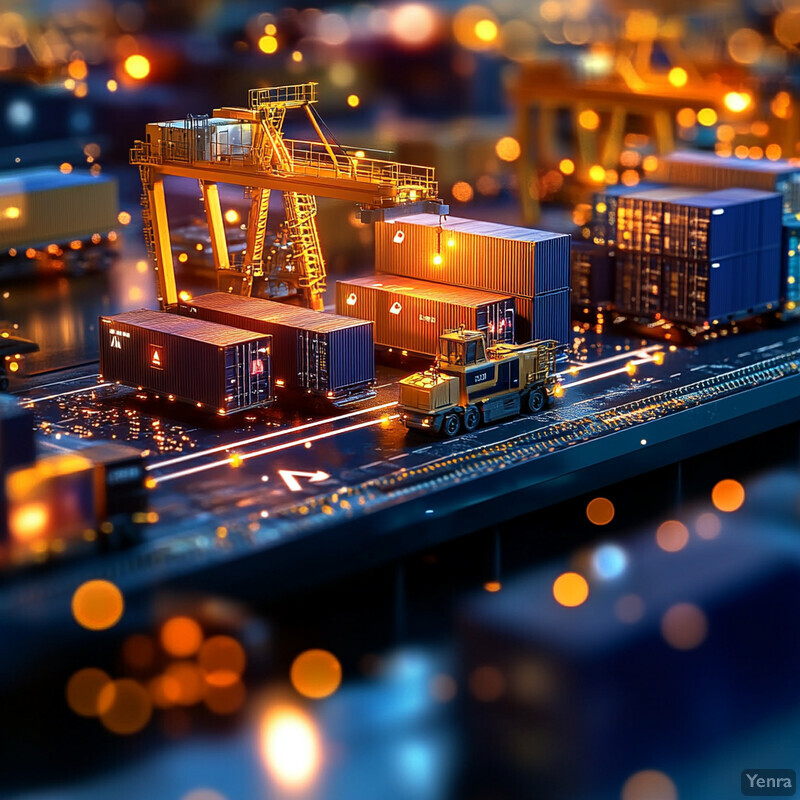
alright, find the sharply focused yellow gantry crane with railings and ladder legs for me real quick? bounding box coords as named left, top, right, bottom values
left=131, top=83, right=448, bottom=309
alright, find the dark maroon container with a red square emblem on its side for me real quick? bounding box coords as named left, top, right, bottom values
left=100, top=309, right=274, bottom=414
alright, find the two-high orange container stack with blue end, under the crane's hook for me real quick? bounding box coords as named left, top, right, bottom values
left=372, top=214, right=570, bottom=344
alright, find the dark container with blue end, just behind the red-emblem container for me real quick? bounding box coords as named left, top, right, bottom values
left=178, top=292, right=375, bottom=405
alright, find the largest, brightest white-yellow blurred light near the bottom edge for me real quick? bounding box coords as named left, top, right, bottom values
left=260, top=706, right=322, bottom=790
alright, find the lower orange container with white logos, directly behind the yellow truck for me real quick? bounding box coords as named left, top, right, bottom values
left=336, top=275, right=514, bottom=356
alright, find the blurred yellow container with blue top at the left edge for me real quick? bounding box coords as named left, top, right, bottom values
left=0, top=172, right=119, bottom=250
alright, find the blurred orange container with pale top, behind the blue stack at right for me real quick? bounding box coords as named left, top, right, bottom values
left=656, top=150, right=800, bottom=214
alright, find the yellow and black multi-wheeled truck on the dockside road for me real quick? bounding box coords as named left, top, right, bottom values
left=399, top=327, right=562, bottom=437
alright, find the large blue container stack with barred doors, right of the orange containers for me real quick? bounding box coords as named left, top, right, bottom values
left=613, top=187, right=781, bottom=326
